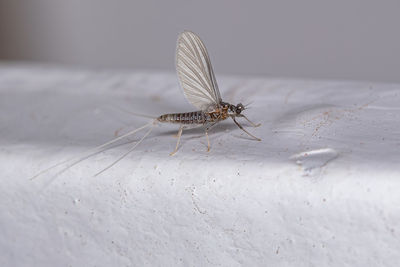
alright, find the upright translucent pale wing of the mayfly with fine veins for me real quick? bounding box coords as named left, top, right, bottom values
left=176, top=31, right=221, bottom=110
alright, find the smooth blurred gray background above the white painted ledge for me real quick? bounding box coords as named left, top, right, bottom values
left=0, top=0, right=400, bottom=82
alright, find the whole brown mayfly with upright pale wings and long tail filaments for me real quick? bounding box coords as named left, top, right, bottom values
left=32, top=31, right=261, bottom=179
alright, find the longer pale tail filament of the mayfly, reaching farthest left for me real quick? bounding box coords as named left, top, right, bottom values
left=30, top=120, right=156, bottom=180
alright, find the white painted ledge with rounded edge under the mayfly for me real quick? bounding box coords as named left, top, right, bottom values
left=0, top=65, right=400, bottom=266
